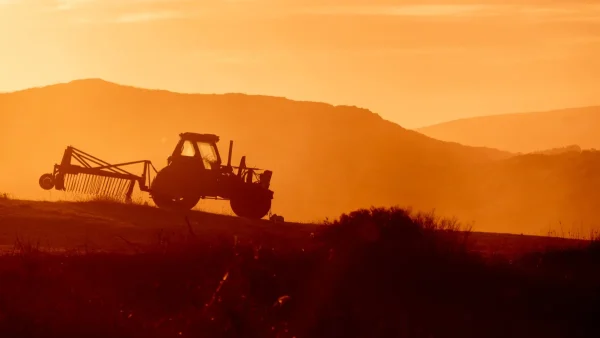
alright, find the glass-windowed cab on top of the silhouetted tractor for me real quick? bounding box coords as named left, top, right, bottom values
left=168, top=133, right=221, bottom=171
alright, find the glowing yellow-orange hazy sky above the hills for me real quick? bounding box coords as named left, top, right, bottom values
left=0, top=0, right=600, bottom=128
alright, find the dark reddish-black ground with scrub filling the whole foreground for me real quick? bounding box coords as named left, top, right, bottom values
left=0, top=198, right=600, bottom=338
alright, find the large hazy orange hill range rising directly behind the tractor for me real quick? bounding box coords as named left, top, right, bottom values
left=0, top=79, right=598, bottom=234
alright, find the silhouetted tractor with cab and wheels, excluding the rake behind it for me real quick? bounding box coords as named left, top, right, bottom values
left=149, top=133, right=273, bottom=219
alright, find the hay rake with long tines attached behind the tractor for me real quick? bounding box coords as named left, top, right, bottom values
left=39, top=147, right=157, bottom=202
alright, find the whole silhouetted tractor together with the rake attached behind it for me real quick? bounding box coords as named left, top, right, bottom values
left=39, top=132, right=273, bottom=219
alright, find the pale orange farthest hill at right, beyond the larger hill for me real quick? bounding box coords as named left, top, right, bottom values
left=416, top=106, right=600, bottom=153
